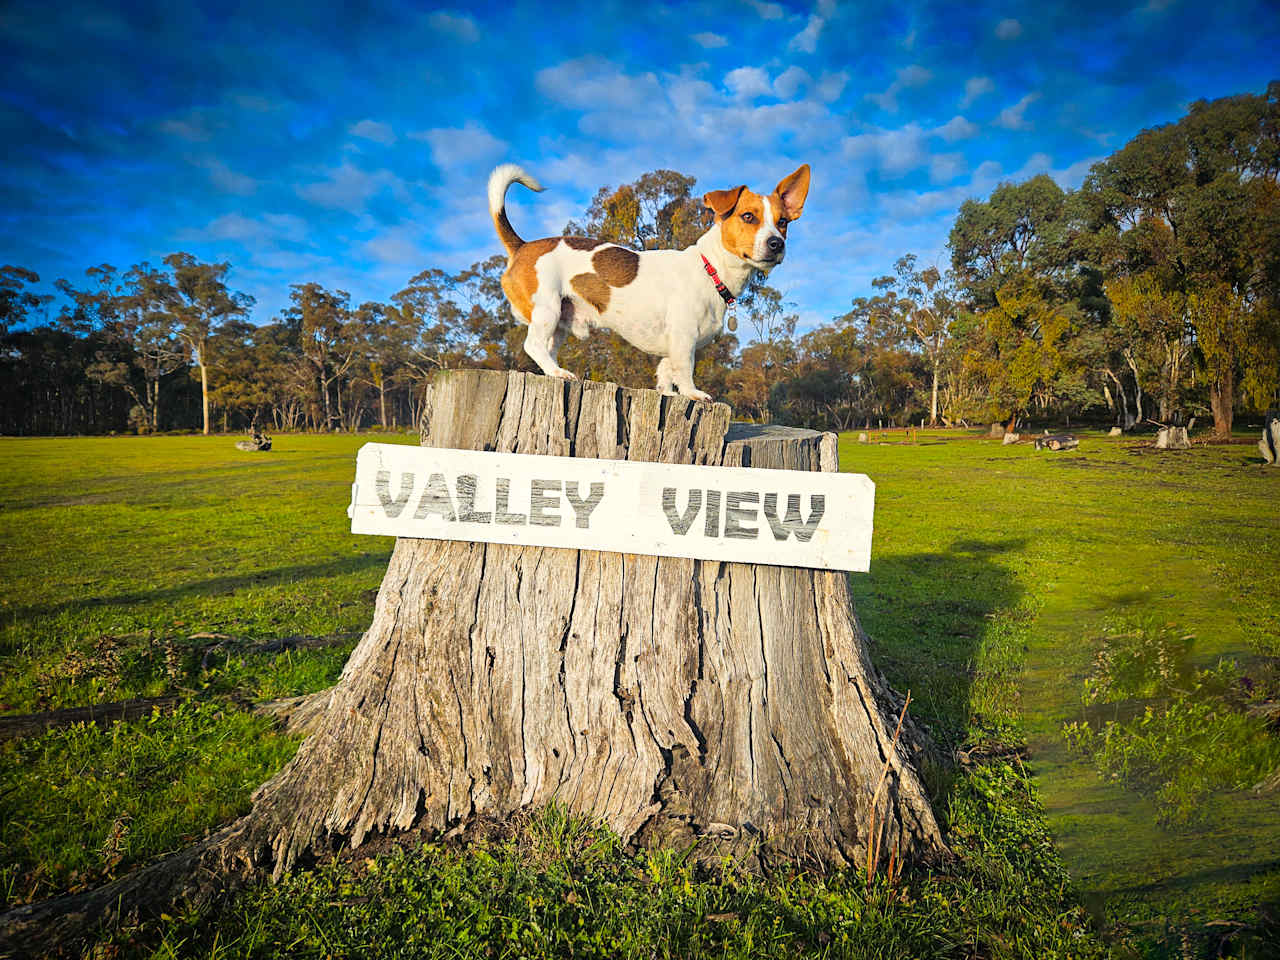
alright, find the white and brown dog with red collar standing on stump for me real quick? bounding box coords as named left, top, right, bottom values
left=489, top=164, right=809, bottom=401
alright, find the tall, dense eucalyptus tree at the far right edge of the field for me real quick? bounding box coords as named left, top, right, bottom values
left=1084, top=82, right=1280, bottom=435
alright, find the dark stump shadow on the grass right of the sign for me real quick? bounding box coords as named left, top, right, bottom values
left=852, top=539, right=1027, bottom=749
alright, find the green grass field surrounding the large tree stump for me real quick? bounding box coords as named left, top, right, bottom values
left=0, top=433, right=1280, bottom=957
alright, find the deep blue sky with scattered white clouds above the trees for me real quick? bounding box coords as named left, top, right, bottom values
left=0, top=0, right=1280, bottom=328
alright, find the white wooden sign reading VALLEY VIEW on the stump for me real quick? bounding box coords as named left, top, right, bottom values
left=347, top=443, right=876, bottom=571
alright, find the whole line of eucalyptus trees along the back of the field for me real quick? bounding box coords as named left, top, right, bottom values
left=0, top=82, right=1280, bottom=435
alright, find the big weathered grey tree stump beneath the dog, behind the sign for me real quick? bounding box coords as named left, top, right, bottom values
left=5, top=370, right=946, bottom=957
